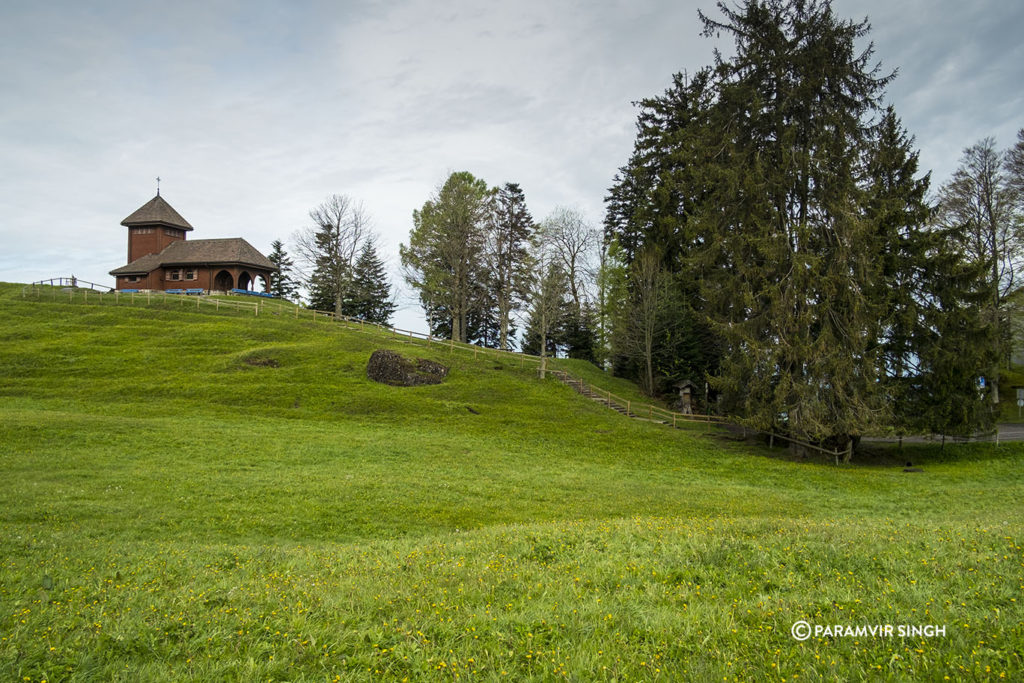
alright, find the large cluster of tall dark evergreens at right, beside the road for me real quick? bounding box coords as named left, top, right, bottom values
left=598, top=0, right=1024, bottom=454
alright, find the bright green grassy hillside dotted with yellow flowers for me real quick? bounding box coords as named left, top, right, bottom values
left=0, top=285, right=1024, bottom=681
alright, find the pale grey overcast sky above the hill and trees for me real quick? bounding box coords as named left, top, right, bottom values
left=0, top=0, right=1024, bottom=329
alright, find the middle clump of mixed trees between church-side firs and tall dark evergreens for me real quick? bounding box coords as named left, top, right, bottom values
left=399, top=171, right=600, bottom=360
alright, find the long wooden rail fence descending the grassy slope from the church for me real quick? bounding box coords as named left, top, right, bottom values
left=22, top=278, right=850, bottom=463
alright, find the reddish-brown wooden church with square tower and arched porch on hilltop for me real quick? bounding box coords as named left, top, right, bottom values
left=111, top=189, right=278, bottom=292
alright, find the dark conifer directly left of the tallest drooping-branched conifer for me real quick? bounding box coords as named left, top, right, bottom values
left=603, top=69, right=723, bottom=395
